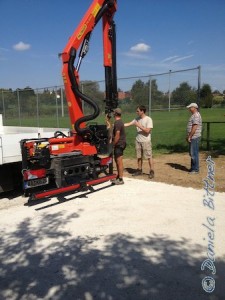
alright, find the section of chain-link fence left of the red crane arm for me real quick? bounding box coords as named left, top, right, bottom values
left=0, top=86, right=68, bottom=127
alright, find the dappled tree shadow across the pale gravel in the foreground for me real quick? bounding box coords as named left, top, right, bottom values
left=0, top=212, right=222, bottom=300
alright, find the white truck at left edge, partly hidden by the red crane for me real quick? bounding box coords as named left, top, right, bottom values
left=0, top=114, right=69, bottom=193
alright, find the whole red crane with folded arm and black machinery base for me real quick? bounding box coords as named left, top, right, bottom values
left=21, top=0, right=118, bottom=201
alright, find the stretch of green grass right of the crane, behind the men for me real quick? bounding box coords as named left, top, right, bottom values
left=123, top=109, right=225, bottom=156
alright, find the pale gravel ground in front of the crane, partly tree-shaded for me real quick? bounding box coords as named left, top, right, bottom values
left=0, top=177, right=225, bottom=300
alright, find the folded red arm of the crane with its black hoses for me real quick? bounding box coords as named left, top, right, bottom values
left=61, top=0, right=118, bottom=138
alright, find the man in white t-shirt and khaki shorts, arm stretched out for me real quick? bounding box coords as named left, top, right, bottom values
left=124, top=105, right=154, bottom=179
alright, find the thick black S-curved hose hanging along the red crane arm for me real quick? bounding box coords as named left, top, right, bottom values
left=68, top=48, right=100, bottom=138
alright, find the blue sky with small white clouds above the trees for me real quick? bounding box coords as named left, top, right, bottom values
left=0, top=0, right=225, bottom=92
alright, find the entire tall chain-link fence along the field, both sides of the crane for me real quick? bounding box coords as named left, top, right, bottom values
left=0, top=66, right=223, bottom=155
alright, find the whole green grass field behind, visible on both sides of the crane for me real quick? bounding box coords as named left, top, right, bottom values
left=4, top=109, right=225, bottom=157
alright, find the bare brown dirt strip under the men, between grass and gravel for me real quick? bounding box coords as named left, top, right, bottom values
left=124, top=153, right=225, bottom=192
